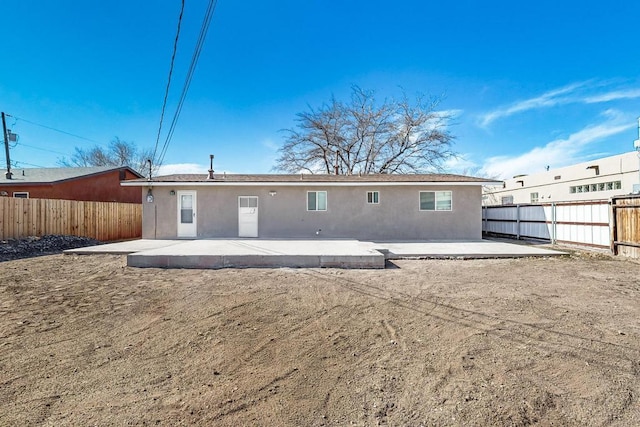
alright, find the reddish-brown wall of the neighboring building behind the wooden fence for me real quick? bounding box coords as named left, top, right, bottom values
left=0, top=170, right=141, bottom=203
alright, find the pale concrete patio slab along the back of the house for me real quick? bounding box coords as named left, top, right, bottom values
left=65, top=239, right=564, bottom=268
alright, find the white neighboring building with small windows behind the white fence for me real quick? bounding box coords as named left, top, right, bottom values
left=482, top=152, right=640, bottom=206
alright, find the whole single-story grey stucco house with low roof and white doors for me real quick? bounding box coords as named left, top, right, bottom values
left=122, top=173, right=497, bottom=241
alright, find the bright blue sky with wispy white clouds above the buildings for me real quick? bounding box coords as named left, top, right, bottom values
left=0, top=0, right=640, bottom=178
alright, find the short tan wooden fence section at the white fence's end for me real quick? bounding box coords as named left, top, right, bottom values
left=611, top=195, right=640, bottom=258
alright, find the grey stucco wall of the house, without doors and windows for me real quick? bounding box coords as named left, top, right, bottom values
left=138, top=185, right=482, bottom=240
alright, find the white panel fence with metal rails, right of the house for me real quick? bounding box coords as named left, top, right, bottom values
left=482, top=200, right=611, bottom=248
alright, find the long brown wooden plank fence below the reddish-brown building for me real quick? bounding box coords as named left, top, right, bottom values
left=0, top=197, right=142, bottom=242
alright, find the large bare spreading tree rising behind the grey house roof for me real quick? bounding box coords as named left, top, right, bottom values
left=274, top=86, right=455, bottom=174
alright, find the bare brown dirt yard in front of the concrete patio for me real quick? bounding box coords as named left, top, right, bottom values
left=0, top=252, right=640, bottom=426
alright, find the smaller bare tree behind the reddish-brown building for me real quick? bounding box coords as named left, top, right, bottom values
left=58, top=137, right=152, bottom=176
